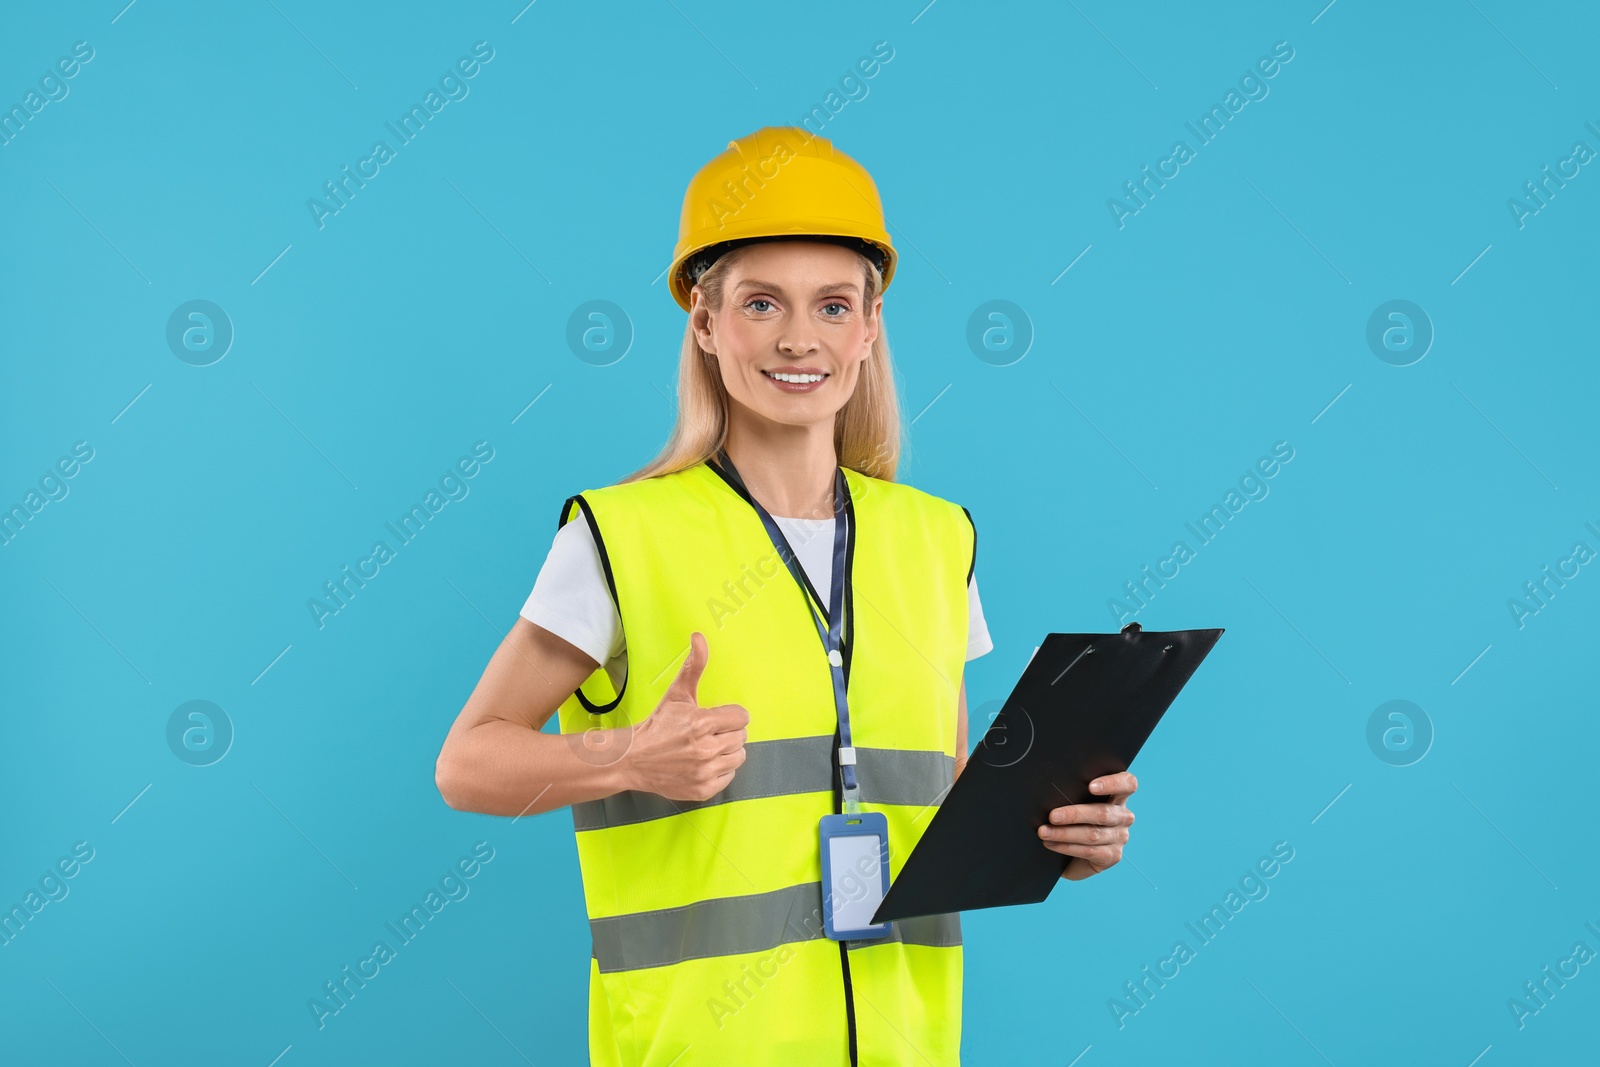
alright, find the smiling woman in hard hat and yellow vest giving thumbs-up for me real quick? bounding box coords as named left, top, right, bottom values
left=437, top=128, right=1136, bottom=1067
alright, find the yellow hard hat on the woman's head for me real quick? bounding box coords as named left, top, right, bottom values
left=669, top=126, right=896, bottom=310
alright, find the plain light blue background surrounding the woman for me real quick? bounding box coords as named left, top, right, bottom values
left=0, top=0, right=1600, bottom=1067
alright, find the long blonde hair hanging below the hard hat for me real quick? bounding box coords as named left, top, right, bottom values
left=622, top=246, right=901, bottom=483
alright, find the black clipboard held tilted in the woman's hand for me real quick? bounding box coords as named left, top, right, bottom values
left=872, top=622, right=1222, bottom=923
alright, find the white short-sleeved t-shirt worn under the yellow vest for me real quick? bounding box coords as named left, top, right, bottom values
left=522, top=515, right=994, bottom=686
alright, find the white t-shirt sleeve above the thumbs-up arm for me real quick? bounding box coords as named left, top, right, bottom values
left=522, top=515, right=622, bottom=664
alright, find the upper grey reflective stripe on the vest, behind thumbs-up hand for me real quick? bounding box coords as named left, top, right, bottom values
left=573, top=736, right=955, bottom=832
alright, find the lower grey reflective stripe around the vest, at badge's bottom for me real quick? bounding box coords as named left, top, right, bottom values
left=589, top=881, right=962, bottom=973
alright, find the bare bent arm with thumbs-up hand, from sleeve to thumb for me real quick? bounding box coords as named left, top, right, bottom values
left=434, top=617, right=749, bottom=816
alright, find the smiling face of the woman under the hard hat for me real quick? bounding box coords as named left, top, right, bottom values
left=690, top=240, right=883, bottom=426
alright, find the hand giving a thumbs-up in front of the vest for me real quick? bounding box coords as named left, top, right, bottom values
left=624, top=633, right=750, bottom=800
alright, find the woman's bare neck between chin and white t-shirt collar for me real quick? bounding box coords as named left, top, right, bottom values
left=725, top=416, right=838, bottom=518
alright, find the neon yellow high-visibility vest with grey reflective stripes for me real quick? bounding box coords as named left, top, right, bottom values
left=560, top=464, right=976, bottom=1067
